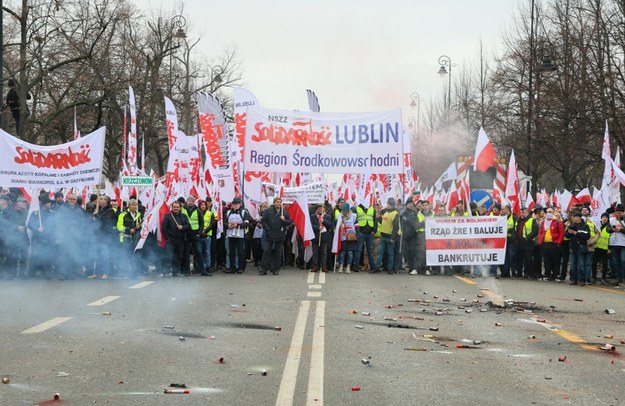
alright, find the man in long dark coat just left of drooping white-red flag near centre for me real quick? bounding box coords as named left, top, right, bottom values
left=260, top=197, right=293, bottom=275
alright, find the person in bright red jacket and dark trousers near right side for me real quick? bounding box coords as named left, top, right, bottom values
left=538, top=207, right=564, bottom=281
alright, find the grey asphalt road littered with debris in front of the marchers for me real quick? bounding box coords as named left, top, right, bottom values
left=0, top=268, right=625, bottom=405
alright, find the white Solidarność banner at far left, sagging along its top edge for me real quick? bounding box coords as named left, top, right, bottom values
left=0, top=127, right=106, bottom=189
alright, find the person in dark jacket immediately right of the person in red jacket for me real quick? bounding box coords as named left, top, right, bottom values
left=565, top=211, right=592, bottom=286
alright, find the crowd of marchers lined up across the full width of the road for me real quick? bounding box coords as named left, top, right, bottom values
left=0, top=189, right=625, bottom=286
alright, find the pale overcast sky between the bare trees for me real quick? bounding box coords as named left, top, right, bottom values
left=135, top=0, right=516, bottom=117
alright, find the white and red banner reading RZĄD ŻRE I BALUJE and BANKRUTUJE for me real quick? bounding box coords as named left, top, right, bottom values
left=425, top=216, right=507, bottom=265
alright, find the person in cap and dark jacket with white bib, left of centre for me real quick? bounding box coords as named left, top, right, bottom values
left=224, top=197, right=252, bottom=274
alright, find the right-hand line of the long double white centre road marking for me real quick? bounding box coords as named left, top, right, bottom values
left=306, top=300, right=326, bottom=405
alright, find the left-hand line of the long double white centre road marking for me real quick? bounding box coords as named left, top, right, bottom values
left=276, top=300, right=310, bottom=406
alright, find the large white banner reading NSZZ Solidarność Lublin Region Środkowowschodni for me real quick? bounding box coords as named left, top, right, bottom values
left=244, top=106, right=403, bottom=174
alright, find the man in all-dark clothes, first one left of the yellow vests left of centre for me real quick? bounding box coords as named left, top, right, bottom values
left=162, top=202, right=191, bottom=277
